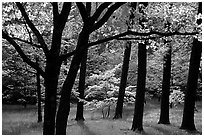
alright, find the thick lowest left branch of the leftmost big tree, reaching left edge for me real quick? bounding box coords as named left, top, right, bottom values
left=2, top=30, right=45, bottom=77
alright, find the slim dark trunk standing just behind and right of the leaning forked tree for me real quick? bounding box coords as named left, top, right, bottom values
left=75, top=50, right=88, bottom=121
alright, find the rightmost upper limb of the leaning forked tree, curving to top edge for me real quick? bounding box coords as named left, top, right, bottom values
left=92, top=2, right=125, bottom=31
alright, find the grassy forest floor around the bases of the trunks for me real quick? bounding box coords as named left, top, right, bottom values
left=2, top=100, right=202, bottom=135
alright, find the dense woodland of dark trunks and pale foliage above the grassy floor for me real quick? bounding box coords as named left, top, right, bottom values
left=2, top=2, right=202, bottom=134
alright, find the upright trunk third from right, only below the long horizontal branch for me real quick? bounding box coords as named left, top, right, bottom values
left=132, top=43, right=147, bottom=131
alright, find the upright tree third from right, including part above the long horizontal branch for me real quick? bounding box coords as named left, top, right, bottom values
left=131, top=2, right=148, bottom=131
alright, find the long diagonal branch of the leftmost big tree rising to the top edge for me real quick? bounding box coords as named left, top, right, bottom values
left=16, top=2, right=49, bottom=56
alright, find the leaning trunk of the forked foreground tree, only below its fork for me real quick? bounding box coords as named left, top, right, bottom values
left=56, top=29, right=89, bottom=135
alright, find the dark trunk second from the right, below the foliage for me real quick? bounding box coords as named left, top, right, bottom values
left=158, top=43, right=171, bottom=124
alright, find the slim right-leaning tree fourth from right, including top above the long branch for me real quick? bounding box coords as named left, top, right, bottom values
left=114, top=2, right=137, bottom=119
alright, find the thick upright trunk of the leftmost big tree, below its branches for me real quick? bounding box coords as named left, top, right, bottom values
left=43, top=57, right=60, bottom=135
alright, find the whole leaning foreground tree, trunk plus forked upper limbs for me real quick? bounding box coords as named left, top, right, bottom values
left=56, top=3, right=124, bottom=134
